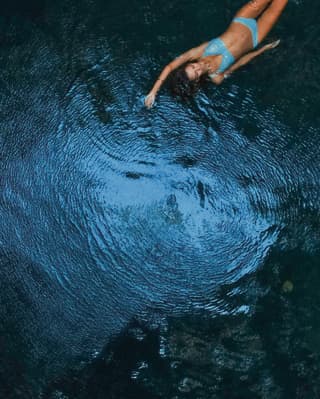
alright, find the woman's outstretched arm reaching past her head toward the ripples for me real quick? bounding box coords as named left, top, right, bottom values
left=144, top=43, right=207, bottom=108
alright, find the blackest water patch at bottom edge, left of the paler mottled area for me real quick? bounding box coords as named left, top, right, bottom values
left=42, top=322, right=162, bottom=399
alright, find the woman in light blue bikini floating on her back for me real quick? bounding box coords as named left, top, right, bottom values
left=145, top=0, right=288, bottom=108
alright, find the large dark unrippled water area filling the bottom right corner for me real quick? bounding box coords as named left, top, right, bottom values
left=43, top=249, right=320, bottom=399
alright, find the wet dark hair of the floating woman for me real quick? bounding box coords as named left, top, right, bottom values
left=169, top=62, right=207, bottom=100
